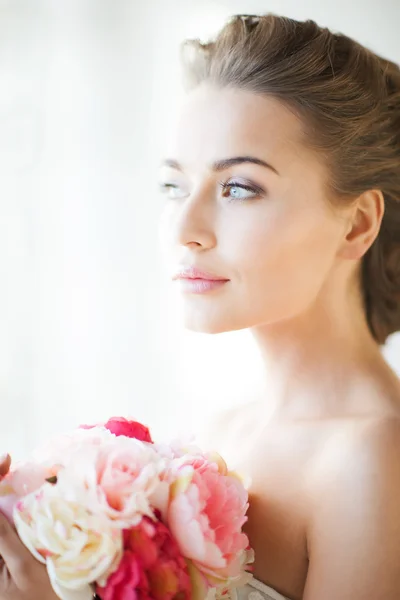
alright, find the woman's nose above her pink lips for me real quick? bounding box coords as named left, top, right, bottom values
left=174, top=190, right=217, bottom=251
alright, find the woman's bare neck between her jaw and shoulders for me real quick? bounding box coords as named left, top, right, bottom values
left=253, top=290, right=385, bottom=418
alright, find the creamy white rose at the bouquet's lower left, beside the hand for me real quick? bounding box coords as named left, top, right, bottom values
left=14, top=484, right=122, bottom=598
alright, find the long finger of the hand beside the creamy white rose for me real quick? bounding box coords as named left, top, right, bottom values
left=0, top=513, right=34, bottom=586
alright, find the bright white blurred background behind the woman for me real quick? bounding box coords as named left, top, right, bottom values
left=0, top=0, right=400, bottom=457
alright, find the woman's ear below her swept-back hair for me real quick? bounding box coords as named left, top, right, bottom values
left=339, top=190, right=385, bottom=260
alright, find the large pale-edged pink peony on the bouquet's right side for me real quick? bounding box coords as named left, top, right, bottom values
left=167, top=456, right=249, bottom=585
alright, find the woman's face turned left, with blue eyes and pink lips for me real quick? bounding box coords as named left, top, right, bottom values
left=161, top=85, right=352, bottom=333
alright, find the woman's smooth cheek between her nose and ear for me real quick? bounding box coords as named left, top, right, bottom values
left=227, top=204, right=339, bottom=307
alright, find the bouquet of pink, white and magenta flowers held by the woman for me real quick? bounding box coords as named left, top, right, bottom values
left=0, top=417, right=252, bottom=600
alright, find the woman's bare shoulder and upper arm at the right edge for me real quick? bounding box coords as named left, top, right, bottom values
left=304, top=417, right=400, bottom=600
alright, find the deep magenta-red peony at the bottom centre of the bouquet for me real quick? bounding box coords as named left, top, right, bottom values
left=97, top=517, right=192, bottom=600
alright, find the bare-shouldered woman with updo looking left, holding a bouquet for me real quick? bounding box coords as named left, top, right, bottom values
left=0, top=15, right=400, bottom=600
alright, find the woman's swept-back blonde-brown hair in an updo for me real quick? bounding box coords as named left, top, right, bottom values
left=183, top=14, right=400, bottom=344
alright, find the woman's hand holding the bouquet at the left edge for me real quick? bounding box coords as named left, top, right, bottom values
left=0, top=454, right=58, bottom=600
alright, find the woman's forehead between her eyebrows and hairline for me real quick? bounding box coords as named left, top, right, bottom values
left=169, top=85, right=305, bottom=169
